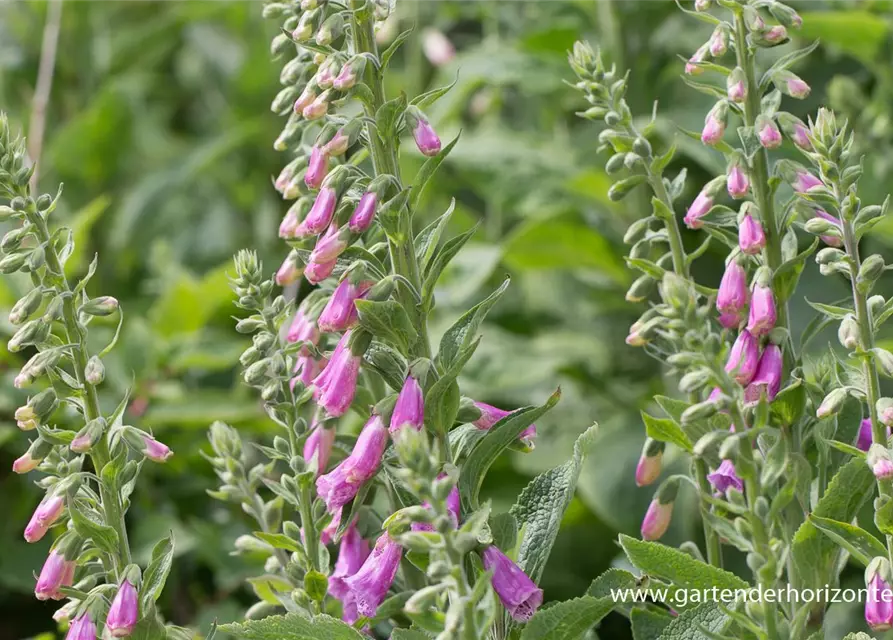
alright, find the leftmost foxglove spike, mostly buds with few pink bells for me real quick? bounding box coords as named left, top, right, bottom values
left=0, top=114, right=181, bottom=640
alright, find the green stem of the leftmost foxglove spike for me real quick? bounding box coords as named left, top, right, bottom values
left=22, top=194, right=131, bottom=578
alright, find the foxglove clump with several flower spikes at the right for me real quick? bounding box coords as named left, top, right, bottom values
left=570, top=0, right=893, bottom=640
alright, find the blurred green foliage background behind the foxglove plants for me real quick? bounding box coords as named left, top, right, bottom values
left=0, top=0, right=893, bottom=640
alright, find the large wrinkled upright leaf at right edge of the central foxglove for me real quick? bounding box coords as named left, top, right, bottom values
left=510, top=425, right=598, bottom=582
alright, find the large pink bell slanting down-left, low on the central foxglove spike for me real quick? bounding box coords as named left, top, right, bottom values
left=316, top=414, right=388, bottom=513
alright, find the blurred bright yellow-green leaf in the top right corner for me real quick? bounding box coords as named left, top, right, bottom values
left=800, top=10, right=890, bottom=64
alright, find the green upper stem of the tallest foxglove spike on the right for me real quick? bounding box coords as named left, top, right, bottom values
left=735, top=10, right=789, bottom=329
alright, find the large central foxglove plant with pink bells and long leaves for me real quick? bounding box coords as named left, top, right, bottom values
left=210, top=0, right=592, bottom=640
